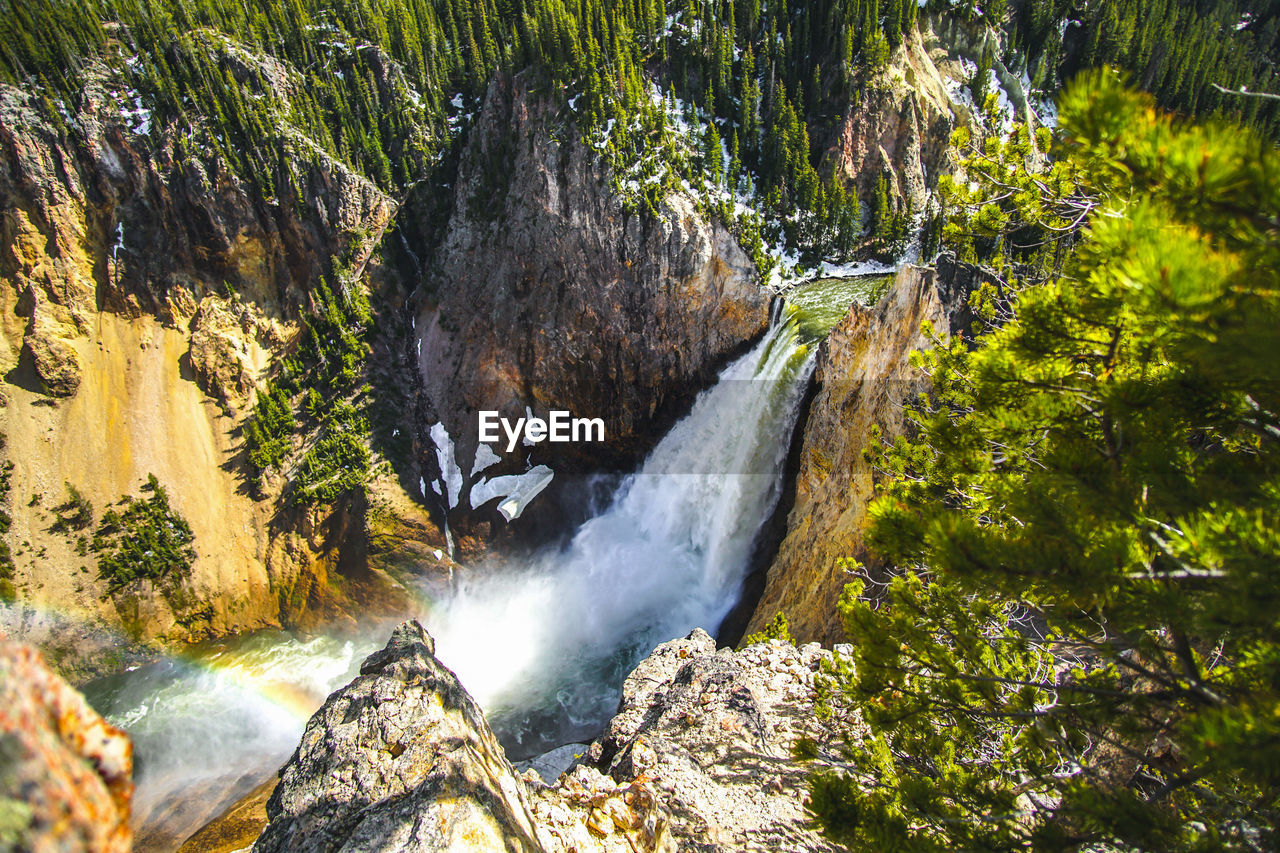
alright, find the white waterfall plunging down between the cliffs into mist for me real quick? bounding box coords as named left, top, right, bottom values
left=430, top=309, right=814, bottom=757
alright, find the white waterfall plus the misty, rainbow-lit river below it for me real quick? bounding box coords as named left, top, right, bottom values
left=86, top=298, right=815, bottom=824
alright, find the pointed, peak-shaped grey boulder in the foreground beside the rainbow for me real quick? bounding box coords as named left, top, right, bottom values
left=253, top=621, right=541, bottom=853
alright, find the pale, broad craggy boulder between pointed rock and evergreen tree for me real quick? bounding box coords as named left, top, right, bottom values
left=561, top=629, right=840, bottom=853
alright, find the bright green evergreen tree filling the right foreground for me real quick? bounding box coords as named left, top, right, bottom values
left=812, top=77, right=1280, bottom=850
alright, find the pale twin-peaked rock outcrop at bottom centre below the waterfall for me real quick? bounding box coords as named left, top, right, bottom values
left=253, top=622, right=829, bottom=853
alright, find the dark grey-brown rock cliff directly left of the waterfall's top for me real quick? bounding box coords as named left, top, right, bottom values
left=417, top=71, right=768, bottom=532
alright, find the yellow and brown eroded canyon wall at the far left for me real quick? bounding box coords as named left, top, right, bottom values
left=0, top=53, right=443, bottom=669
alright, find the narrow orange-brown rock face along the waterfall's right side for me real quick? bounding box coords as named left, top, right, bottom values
left=748, top=259, right=974, bottom=644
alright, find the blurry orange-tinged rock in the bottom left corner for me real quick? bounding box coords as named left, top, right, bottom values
left=0, top=639, right=133, bottom=853
